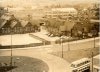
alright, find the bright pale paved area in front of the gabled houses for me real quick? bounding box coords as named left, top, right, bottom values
left=0, top=34, right=42, bottom=46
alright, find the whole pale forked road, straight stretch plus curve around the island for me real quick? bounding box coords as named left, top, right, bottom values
left=0, top=38, right=99, bottom=72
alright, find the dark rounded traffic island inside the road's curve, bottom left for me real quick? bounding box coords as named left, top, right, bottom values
left=0, top=56, right=49, bottom=72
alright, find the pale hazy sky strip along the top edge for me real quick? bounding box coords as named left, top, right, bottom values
left=0, top=0, right=99, bottom=5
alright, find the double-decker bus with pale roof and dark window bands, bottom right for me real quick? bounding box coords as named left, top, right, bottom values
left=71, top=58, right=90, bottom=72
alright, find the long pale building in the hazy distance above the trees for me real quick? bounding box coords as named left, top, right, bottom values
left=45, top=8, right=77, bottom=19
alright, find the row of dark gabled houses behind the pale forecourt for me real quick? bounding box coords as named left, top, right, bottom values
left=0, top=13, right=38, bottom=35
